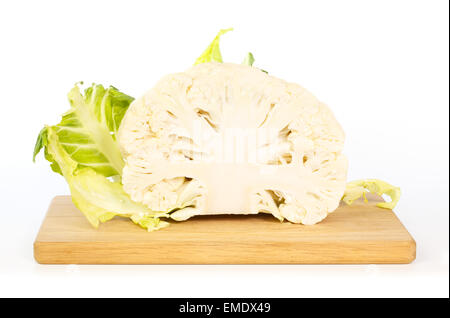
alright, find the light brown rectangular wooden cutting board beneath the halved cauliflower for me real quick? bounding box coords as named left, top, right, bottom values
left=34, top=196, right=416, bottom=264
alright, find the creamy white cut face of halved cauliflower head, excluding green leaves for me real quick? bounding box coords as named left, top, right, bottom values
left=119, top=62, right=347, bottom=224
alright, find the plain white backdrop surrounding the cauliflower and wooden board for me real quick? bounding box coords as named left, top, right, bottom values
left=0, top=0, right=449, bottom=297
